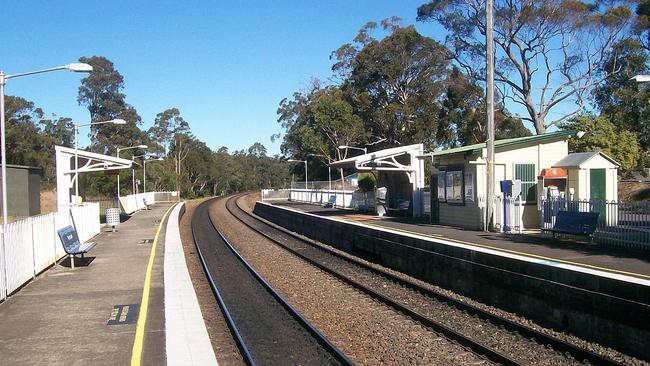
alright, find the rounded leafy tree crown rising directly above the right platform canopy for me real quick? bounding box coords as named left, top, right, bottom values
left=343, top=26, right=449, bottom=146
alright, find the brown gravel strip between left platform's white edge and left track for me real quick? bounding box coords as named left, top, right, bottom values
left=180, top=199, right=244, bottom=366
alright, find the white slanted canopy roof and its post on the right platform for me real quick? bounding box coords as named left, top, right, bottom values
left=329, top=144, right=424, bottom=216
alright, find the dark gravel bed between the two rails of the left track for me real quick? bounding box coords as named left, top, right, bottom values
left=192, top=201, right=339, bottom=366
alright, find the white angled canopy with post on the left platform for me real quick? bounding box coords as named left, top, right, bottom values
left=54, top=146, right=132, bottom=211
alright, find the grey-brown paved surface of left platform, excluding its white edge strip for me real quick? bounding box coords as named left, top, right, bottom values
left=0, top=203, right=171, bottom=366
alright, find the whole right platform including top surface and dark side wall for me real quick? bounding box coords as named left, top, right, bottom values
left=254, top=201, right=650, bottom=359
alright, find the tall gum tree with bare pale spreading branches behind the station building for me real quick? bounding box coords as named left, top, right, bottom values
left=417, top=0, right=632, bottom=134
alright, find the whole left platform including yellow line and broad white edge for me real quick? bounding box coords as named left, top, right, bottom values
left=0, top=204, right=216, bottom=365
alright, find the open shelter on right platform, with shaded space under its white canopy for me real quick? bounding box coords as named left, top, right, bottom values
left=329, top=144, right=425, bottom=216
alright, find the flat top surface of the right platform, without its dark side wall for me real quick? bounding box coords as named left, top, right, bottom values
left=272, top=202, right=650, bottom=280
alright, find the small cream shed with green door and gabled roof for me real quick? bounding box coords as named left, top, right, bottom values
left=553, top=152, right=620, bottom=201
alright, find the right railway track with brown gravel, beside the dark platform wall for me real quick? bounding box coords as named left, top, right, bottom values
left=226, top=195, right=621, bottom=365
